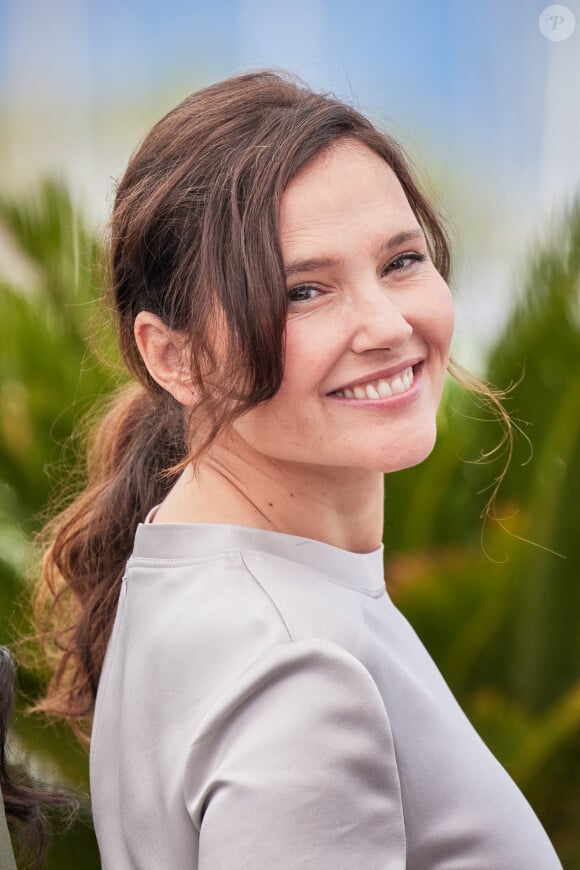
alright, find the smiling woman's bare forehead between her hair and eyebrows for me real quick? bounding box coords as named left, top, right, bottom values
left=280, top=140, right=419, bottom=259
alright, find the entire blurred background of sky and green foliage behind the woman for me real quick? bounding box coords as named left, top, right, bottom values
left=0, top=0, right=580, bottom=870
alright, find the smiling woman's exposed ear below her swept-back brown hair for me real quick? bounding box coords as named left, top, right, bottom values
left=134, top=311, right=198, bottom=407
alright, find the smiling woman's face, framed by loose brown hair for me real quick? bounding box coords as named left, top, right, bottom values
left=233, top=141, right=453, bottom=472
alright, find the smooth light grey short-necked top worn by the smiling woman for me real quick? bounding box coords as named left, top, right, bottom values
left=91, top=523, right=561, bottom=870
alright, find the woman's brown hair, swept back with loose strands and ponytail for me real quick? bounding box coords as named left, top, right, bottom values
left=35, top=71, right=508, bottom=736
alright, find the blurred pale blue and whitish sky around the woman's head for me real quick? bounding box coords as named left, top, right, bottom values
left=0, top=0, right=580, bottom=356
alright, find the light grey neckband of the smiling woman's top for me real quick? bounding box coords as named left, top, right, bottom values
left=133, top=508, right=385, bottom=594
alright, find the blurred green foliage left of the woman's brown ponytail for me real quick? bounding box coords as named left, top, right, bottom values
left=0, top=182, right=118, bottom=870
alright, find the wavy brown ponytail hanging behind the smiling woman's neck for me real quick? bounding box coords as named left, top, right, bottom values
left=35, top=384, right=186, bottom=736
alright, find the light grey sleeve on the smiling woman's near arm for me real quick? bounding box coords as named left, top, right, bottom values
left=184, top=639, right=405, bottom=870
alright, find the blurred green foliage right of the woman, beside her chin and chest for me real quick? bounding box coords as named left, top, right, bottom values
left=386, top=199, right=580, bottom=868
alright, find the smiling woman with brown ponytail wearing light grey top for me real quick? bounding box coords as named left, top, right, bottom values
left=36, top=72, right=560, bottom=870
